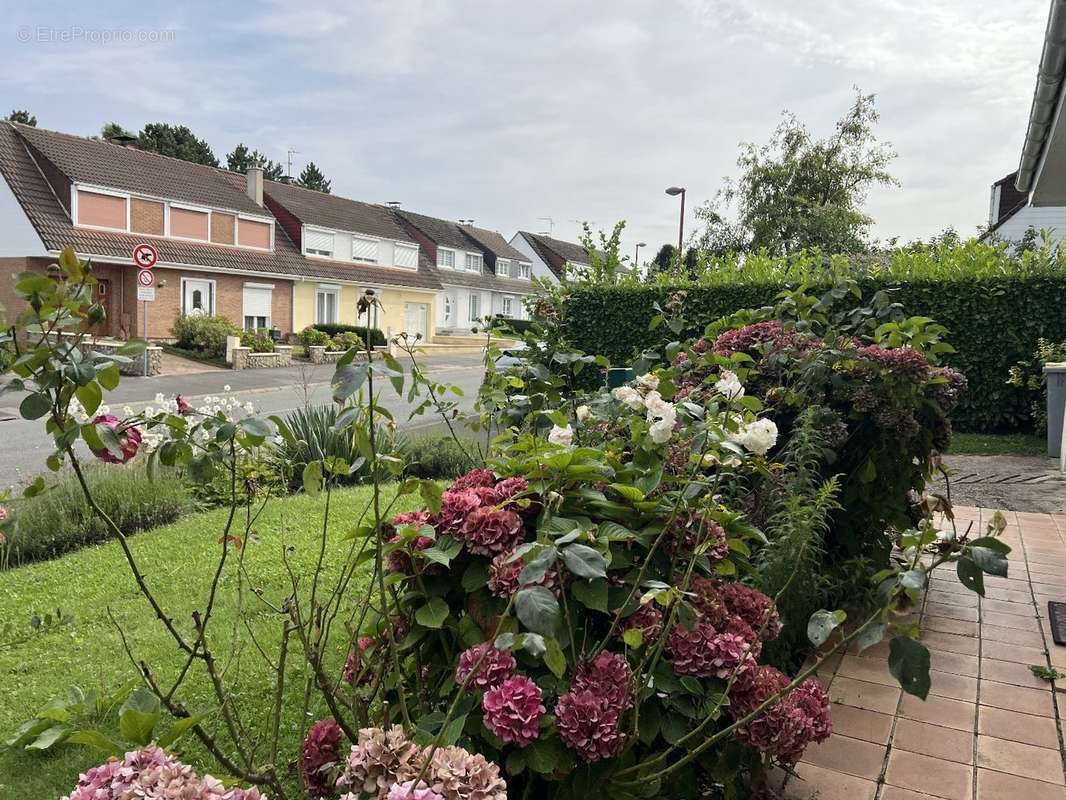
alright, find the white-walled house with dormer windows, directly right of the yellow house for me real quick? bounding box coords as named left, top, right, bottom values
left=393, top=209, right=535, bottom=335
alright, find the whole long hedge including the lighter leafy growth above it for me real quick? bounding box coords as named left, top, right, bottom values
left=562, top=242, right=1066, bottom=432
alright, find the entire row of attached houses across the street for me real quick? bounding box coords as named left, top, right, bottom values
left=0, top=123, right=587, bottom=341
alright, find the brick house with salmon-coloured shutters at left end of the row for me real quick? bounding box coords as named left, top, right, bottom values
left=0, top=123, right=319, bottom=339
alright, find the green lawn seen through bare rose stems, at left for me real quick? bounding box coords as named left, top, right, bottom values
left=0, top=487, right=416, bottom=799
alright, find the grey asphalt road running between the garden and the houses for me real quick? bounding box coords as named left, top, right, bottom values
left=0, top=354, right=482, bottom=487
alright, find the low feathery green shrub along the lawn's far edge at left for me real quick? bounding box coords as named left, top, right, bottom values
left=9, top=465, right=195, bottom=564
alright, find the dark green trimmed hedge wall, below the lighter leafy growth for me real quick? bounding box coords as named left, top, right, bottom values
left=564, top=275, right=1066, bottom=432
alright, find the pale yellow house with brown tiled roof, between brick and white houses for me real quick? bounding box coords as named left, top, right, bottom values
left=263, top=181, right=440, bottom=340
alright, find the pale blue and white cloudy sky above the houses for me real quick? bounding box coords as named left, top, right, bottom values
left=0, top=0, right=1048, bottom=256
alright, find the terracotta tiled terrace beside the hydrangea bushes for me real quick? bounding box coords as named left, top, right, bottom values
left=767, top=508, right=1066, bottom=800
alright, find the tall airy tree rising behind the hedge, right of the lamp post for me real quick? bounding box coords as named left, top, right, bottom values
left=696, top=90, right=898, bottom=254
